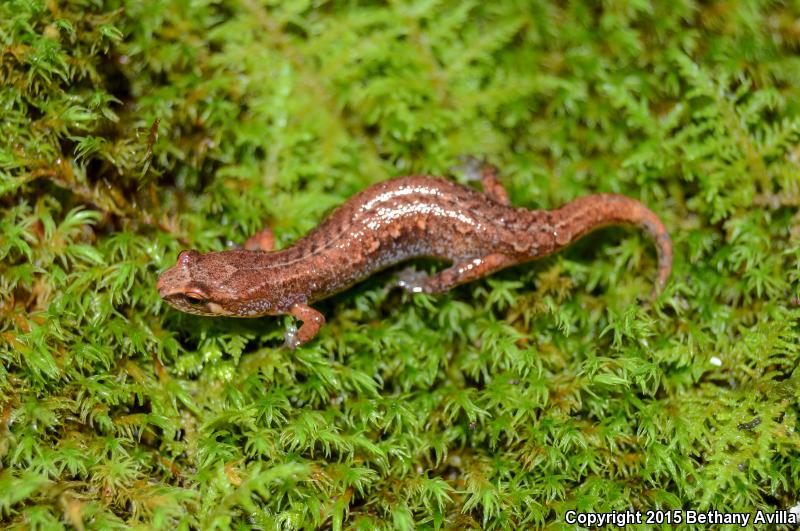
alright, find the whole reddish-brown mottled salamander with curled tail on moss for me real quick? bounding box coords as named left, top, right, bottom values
left=158, top=166, right=672, bottom=348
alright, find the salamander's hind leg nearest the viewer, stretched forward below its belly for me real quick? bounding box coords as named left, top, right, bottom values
left=394, top=253, right=515, bottom=294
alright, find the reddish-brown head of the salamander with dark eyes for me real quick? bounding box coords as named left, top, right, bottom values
left=156, top=250, right=278, bottom=317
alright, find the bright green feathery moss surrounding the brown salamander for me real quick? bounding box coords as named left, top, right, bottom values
left=0, top=0, right=800, bottom=529
